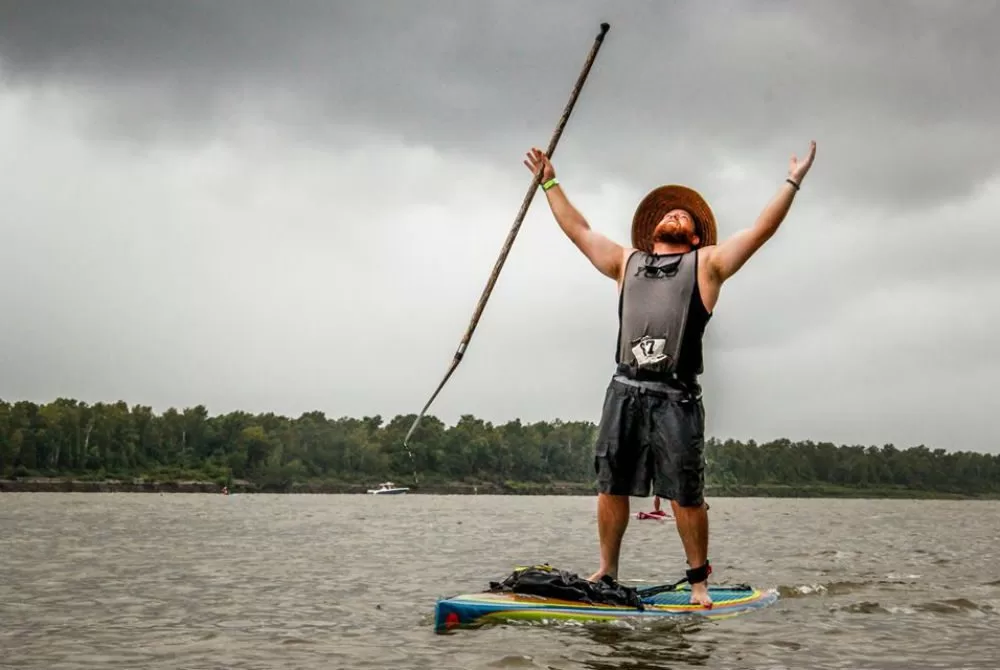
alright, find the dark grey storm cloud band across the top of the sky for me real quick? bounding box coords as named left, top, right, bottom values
left=0, top=0, right=1000, bottom=209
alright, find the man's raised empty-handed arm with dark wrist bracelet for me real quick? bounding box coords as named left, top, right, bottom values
left=708, top=142, right=816, bottom=283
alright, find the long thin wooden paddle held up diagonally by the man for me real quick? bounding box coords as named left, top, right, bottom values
left=403, top=23, right=611, bottom=472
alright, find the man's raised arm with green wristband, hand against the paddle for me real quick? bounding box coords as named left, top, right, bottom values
left=524, top=148, right=625, bottom=281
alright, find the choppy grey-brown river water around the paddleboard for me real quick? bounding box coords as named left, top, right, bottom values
left=0, top=493, right=1000, bottom=670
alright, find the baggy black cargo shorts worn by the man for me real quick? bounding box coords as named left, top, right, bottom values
left=594, top=375, right=705, bottom=507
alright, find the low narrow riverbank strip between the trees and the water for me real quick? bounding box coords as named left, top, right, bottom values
left=0, top=477, right=1000, bottom=500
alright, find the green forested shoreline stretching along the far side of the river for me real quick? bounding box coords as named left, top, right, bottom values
left=0, top=398, right=1000, bottom=497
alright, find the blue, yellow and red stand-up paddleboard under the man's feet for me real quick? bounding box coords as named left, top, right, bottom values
left=434, top=568, right=778, bottom=633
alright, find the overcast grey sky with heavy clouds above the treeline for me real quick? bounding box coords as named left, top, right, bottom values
left=0, top=0, right=1000, bottom=452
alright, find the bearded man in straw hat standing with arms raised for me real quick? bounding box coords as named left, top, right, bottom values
left=524, top=142, right=816, bottom=606
